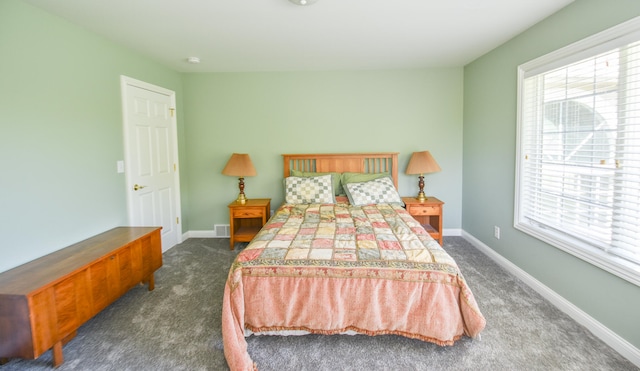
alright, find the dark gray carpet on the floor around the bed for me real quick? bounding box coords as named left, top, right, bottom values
left=0, top=237, right=638, bottom=371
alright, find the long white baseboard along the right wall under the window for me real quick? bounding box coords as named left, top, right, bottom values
left=462, top=230, right=640, bottom=367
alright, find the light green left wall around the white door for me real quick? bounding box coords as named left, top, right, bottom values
left=0, top=0, right=182, bottom=271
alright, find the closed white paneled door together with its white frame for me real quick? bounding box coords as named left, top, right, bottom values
left=121, top=76, right=182, bottom=251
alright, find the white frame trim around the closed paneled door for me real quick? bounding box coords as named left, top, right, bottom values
left=120, top=75, right=183, bottom=252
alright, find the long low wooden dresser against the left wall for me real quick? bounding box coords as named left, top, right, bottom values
left=0, top=227, right=162, bottom=367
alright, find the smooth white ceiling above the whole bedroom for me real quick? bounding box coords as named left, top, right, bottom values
left=25, top=0, right=573, bottom=72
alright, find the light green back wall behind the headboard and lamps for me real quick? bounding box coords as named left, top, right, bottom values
left=184, top=68, right=462, bottom=230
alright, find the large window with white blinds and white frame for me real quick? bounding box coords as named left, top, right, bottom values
left=515, top=17, right=640, bottom=286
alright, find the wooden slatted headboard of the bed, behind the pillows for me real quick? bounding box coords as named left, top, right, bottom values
left=282, top=152, right=398, bottom=189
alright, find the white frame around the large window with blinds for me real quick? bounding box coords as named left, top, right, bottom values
left=514, top=17, right=640, bottom=286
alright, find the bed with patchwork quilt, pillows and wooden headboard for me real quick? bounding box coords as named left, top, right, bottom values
left=222, top=153, right=486, bottom=370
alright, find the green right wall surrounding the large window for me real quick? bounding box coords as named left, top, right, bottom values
left=462, top=0, right=640, bottom=348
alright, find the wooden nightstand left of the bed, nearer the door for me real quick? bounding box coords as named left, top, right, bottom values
left=229, top=198, right=271, bottom=250
